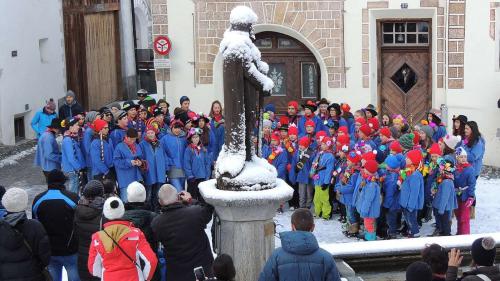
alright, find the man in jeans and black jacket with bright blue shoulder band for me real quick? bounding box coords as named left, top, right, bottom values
left=33, top=170, right=80, bottom=281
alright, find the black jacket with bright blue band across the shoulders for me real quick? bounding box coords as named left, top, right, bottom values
left=32, top=185, right=78, bottom=256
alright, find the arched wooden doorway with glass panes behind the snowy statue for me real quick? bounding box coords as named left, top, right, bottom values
left=255, top=32, right=321, bottom=114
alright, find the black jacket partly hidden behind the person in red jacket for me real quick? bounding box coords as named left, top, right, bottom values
left=75, top=197, right=106, bottom=281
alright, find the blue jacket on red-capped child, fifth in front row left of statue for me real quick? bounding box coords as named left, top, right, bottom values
left=90, top=138, right=114, bottom=177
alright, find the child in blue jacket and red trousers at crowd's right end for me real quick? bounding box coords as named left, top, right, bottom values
left=455, top=147, right=476, bottom=235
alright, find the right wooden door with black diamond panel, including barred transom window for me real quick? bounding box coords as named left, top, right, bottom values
left=379, top=22, right=432, bottom=124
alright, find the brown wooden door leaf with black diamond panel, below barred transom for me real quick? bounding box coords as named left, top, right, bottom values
left=380, top=49, right=432, bottom=124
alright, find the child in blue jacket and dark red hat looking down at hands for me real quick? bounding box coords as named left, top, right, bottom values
left=113, top=128, right=147, bottom=202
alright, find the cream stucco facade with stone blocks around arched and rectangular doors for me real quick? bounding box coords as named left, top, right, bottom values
left=152, top=0, right=500, bottom=166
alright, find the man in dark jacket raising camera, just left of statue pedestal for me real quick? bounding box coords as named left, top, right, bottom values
left=151, top=184, right=214, bottom=281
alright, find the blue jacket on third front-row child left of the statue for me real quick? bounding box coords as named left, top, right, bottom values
left=139, top=140, right=167, bottom=185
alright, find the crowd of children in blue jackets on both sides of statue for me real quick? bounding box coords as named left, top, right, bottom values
left=35, top=91, right=485, bottom=240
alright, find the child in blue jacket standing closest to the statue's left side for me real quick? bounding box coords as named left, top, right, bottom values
left=183, top=128, right=212, bottom=200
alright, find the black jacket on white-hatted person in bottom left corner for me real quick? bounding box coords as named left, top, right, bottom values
left=0, top=212, right=50, bottom=281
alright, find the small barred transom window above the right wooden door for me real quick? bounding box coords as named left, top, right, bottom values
left=382, top=22, right=429, bottom=46
